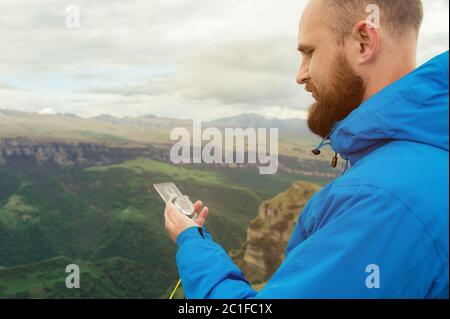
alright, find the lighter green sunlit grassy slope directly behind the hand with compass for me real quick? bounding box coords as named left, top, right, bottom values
left=87, top=158, right=262, bottom=249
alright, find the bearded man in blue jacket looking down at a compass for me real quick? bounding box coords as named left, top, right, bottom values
left=165, top=0, right=449, bottom=298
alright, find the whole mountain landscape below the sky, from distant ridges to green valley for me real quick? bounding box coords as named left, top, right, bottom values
left=0, top=110, right=339, bottom=298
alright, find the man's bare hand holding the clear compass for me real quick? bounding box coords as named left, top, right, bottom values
left=164, top=201, right=208, bottom=241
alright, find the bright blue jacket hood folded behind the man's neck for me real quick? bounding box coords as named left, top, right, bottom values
left=330, top=51, right=449, bottom=164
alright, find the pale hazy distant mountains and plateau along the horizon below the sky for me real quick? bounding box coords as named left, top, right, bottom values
left=0, top=110, right=320, bottom=158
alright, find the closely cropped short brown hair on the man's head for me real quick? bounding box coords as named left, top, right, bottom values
left=324, top=0, right=423, bottom=44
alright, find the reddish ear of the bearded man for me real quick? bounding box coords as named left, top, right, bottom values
left=352, top=21, right=380, bottom=65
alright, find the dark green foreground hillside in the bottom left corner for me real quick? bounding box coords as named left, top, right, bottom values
left=0, top=256, right=171, bottom=299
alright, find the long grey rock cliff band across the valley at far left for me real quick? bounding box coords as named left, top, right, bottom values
left=0, top=139, right=167, bottom=166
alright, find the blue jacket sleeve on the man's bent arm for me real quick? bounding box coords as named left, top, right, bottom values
left=177, top=186, right=440, bottom=299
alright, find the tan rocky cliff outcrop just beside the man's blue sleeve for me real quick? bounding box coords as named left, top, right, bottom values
left=230, top=182, right=320, bottom=284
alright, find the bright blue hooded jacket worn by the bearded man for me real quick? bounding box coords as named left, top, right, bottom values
left=177, top=52, right=449, bottom=299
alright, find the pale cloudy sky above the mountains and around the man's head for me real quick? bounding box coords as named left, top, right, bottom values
left=0, top=0, right=449, bottom=120
